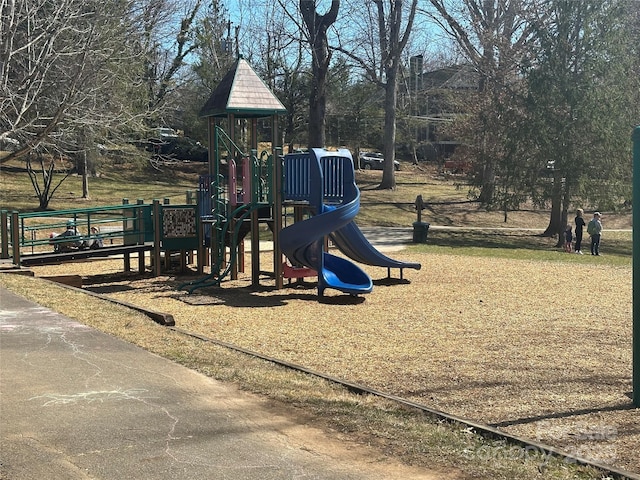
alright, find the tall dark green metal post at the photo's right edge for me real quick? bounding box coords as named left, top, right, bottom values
left=633, top=125, right=640, bottom=407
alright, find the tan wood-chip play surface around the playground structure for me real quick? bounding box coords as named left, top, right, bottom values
left=11, top=244, right=640, bottom=474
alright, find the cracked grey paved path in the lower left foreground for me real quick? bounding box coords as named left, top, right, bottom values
left=0, top=289, right=448, bottom=480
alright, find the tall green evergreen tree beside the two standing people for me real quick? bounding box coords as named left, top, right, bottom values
left=527, top=0, right=638, bottom=242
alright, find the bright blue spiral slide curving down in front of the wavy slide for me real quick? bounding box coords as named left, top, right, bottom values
left=280, top=149, right=373, bottom=296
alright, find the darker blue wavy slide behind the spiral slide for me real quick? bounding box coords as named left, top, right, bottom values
left=331, top=222, right=422, bottom=270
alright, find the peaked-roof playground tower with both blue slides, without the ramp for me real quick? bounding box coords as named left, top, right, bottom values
left=181, top=58, right=420, bottom=296
